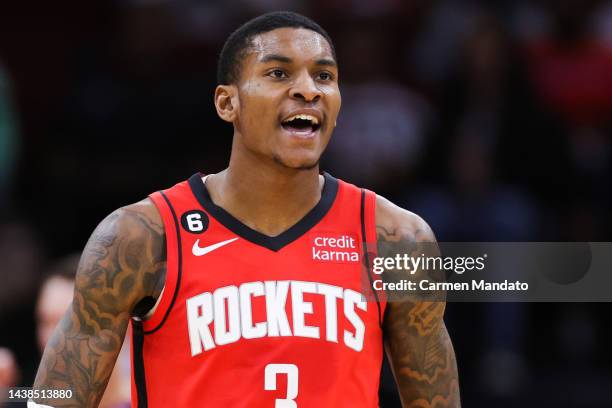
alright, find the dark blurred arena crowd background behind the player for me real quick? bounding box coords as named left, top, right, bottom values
left=0, top=0, right=612, bottom=408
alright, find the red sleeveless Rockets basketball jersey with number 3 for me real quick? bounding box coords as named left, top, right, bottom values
left=132, top=174, right=385, bottom=408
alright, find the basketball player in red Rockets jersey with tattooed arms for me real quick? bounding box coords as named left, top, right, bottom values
left=31, top=12, right=460, bottom=408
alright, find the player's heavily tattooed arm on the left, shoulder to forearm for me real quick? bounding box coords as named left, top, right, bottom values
left=34, top=199, right=166, bottom=408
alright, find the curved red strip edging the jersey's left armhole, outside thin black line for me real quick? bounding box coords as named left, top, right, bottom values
left=142, top=191, right=183, bottom=335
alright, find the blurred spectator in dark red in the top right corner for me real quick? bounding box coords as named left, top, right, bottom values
left=528, top=0, right=612, bottom=127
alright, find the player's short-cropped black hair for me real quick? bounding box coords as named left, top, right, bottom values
left=217, top=11, right=336, bottom=85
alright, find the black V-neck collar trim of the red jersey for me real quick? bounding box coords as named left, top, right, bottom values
left=189, top=173, right=338, bottom=252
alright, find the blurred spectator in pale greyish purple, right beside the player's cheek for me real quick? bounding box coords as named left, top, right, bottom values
left=327, top=81, right=432, bottom=191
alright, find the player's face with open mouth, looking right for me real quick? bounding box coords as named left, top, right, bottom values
left=234, top=28, right=340, bottom=169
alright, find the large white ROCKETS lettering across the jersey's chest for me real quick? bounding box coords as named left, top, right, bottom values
left=186, top=281, right=368, bottom=356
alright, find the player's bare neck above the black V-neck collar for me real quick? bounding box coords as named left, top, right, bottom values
left=206, top=143, right=323, bottom=236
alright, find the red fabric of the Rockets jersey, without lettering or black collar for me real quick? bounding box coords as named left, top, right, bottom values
left=132, top=175, right=384, bottom=408
